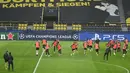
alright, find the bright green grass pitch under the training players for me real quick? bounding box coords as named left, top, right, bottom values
left=0, top=41, right=130, bottom=73
